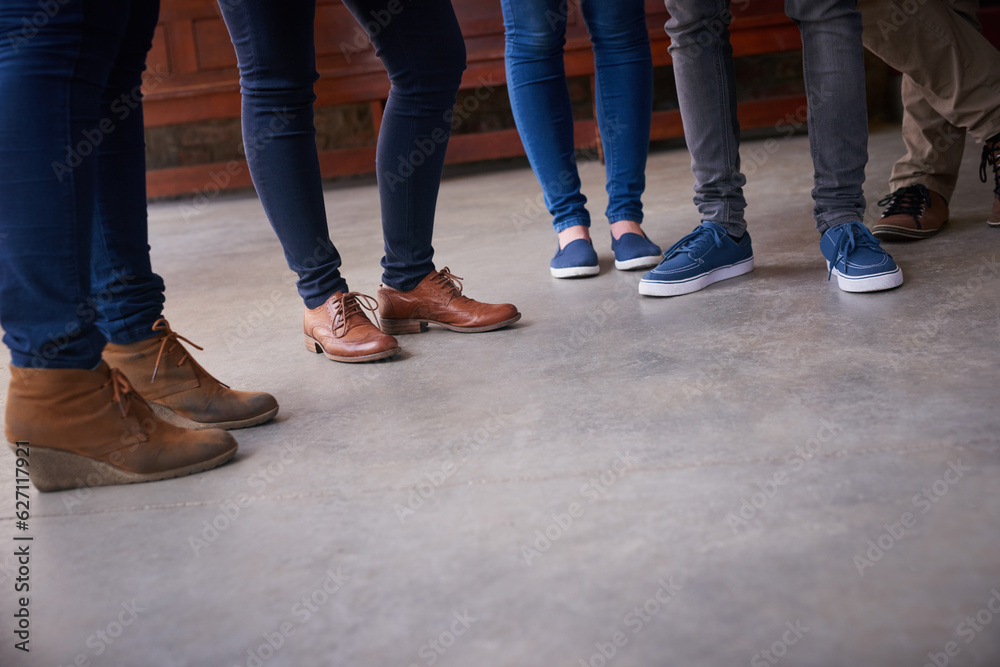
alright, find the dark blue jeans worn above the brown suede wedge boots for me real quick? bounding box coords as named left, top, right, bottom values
left=0, top=0, right=163, bottom=368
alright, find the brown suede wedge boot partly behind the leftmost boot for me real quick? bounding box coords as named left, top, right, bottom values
left=104, top=318, right=278, bottom=429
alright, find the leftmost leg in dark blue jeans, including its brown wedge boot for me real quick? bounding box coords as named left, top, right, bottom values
left=0, top=0, right=236, bottom=491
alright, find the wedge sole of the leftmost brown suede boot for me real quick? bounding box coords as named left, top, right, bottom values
left=8, top=443, right=237, bottom=492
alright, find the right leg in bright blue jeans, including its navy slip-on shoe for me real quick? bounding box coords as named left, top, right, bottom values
left=582, top=0, right=661, bottom=269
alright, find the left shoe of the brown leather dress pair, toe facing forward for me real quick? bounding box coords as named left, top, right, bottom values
left=302, top=292, right=399, bottom=363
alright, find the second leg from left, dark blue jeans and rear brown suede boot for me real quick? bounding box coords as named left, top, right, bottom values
left=83, top=0, right=278, bottom=428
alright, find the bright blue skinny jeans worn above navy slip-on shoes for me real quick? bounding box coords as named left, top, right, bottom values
left=500, top=0, right=653, bottom=232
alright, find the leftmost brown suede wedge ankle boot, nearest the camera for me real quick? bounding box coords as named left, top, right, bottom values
left=4, top=363, right=236, bottom=491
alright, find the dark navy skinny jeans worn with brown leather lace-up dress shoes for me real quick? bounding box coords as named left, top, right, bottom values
left=219, top=0, right=465, bottom=308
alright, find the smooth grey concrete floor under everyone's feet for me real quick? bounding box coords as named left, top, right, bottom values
left=0, top=128, right=1000, bottom=667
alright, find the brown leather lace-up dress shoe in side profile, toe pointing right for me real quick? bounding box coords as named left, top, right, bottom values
left=378, top=267, right=521, bottom=334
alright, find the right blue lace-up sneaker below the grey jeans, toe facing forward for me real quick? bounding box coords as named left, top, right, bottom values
left=819, top=222, right=903, bottom=292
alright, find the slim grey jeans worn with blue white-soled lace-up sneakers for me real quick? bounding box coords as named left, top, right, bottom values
left=666, top=0, right=868, bottom=237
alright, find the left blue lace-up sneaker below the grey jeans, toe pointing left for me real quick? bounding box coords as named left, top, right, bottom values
left=639, top=222, right=753, bottom=296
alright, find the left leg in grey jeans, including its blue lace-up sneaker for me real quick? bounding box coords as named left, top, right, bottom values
left=639, top=0, right=753, bottom=296
